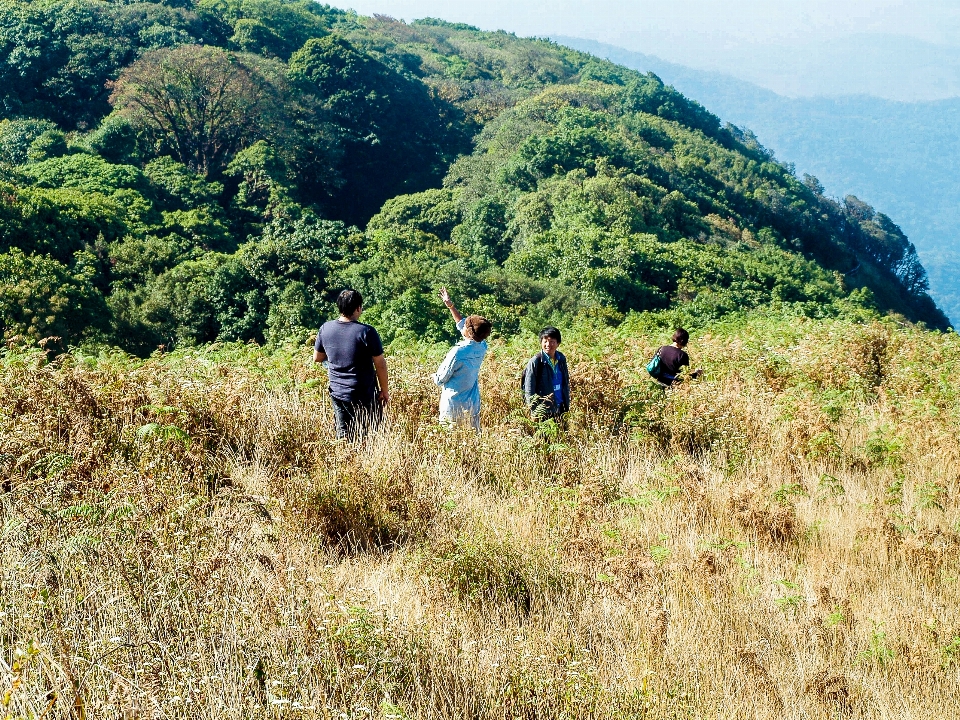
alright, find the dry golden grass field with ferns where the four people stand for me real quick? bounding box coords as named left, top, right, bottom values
left=0, top=320, right=960, bottom=719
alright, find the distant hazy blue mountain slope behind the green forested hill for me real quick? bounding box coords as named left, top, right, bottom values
left=553, top=37, right=960, bottom=323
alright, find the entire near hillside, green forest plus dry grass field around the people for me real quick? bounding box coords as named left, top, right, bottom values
left=0, top=0, right=960, bottom=720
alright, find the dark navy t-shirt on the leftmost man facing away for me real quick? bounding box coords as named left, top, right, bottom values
left=314, top=320, right=383, bottom=402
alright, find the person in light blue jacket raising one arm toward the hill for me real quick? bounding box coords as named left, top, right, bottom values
left=433, top=288, right=493, bottom=431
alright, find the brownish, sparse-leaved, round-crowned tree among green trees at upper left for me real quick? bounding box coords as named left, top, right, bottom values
left=110, top=45, right=286, bottom=178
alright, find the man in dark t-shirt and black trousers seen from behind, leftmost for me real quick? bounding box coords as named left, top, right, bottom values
left=313, top=290, right=390, bottom=442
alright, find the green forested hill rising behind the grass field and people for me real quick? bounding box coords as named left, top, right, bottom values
left=0, top=0, right=947, bottom=353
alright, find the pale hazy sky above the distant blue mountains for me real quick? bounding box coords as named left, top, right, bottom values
left=333, top=0, right=960, bottom=100
